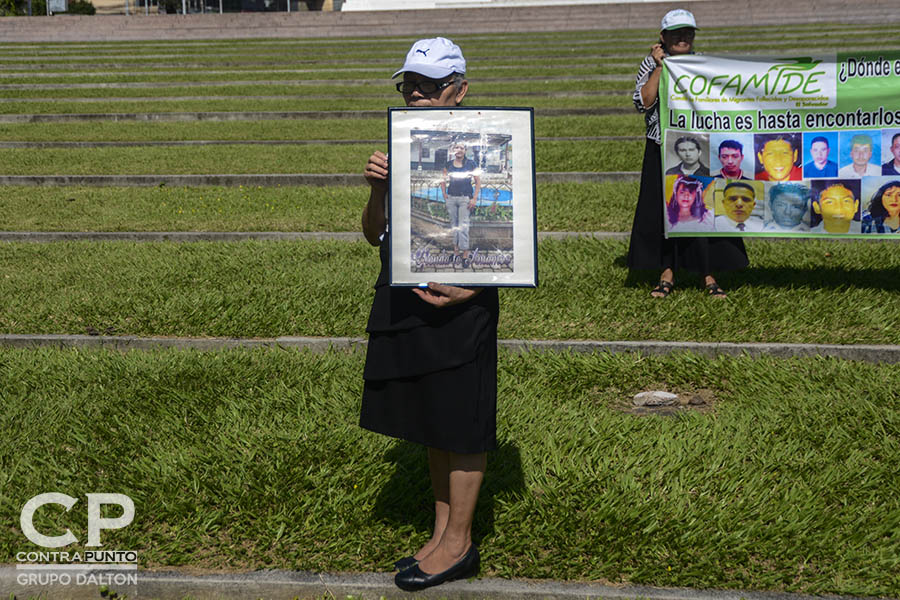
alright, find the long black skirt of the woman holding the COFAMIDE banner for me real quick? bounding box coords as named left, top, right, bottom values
left=628, top=139, right=750, bottom=275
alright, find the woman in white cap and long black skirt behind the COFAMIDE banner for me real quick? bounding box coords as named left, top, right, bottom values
left=628, top=9, right=749, bottom=298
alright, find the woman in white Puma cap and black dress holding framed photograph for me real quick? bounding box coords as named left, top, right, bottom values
left=360, top=38, right=499, bottom=590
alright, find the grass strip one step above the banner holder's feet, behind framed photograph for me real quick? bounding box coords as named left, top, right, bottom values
left=0, top=178, right=638, bottom=231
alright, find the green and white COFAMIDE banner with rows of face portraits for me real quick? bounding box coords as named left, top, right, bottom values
left=660, top=52, right=900, bottom=238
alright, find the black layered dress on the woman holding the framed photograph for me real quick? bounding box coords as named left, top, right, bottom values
left=360, top=233, right=500, bottom=454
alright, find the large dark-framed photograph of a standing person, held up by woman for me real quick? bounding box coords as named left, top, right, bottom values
left=388, top=107, right=537, bottom=287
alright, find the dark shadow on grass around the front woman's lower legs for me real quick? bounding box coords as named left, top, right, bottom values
left=372, top=440, right=525, bottom=544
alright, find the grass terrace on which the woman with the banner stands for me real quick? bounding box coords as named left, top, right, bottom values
left=0, top=239, right=900, bottom=344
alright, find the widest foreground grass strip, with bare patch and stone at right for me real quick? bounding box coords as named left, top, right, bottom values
left=0, top=349, right=900, bottom=597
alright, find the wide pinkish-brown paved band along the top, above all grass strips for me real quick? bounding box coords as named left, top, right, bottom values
left=0, top=0, right=900, bottom=42
